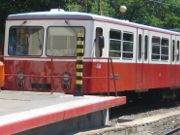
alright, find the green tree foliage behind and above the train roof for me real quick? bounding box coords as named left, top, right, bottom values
left=0, top=0, right=180, bottom=33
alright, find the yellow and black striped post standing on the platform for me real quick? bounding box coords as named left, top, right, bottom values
left=75, top=32, right=85, bottom=96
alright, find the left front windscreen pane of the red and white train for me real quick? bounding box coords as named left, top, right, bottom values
left=8, top=26, right=44, bottom=56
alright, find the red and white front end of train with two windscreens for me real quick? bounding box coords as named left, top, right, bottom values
left=4, top=10, right=93, bottom=92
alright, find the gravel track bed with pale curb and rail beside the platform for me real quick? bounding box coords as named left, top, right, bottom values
left=77, top=98, right=180, bottom=135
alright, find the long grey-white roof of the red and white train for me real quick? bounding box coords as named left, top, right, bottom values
left=7, top=9, right=180, bottom=36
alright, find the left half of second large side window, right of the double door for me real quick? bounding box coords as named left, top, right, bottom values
left=152, top=36, right=160, bottom=60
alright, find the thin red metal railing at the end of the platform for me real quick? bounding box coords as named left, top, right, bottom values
left=0, top=56, right=118, bottom=96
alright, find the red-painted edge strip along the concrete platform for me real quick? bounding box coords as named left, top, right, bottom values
left=0, top=94, right=126, bottom=135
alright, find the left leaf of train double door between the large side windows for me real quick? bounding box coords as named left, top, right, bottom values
left=136, top=29, right=143, bottom=90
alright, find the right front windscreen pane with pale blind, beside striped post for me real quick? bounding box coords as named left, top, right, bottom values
left=46, top=27, right=84, bottom=56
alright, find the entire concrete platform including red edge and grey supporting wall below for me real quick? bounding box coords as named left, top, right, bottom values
left=0, top=90, right=126, bottom=135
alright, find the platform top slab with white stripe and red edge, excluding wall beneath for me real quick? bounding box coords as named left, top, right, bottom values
left=0, top=90, right=126, bottom=135
